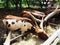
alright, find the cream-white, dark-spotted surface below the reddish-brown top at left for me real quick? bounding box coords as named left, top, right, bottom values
left=3, top=19, right=32, bottom=33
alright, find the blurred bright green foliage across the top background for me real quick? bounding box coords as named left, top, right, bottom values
left=0, top=0, right=60, bottom=8
